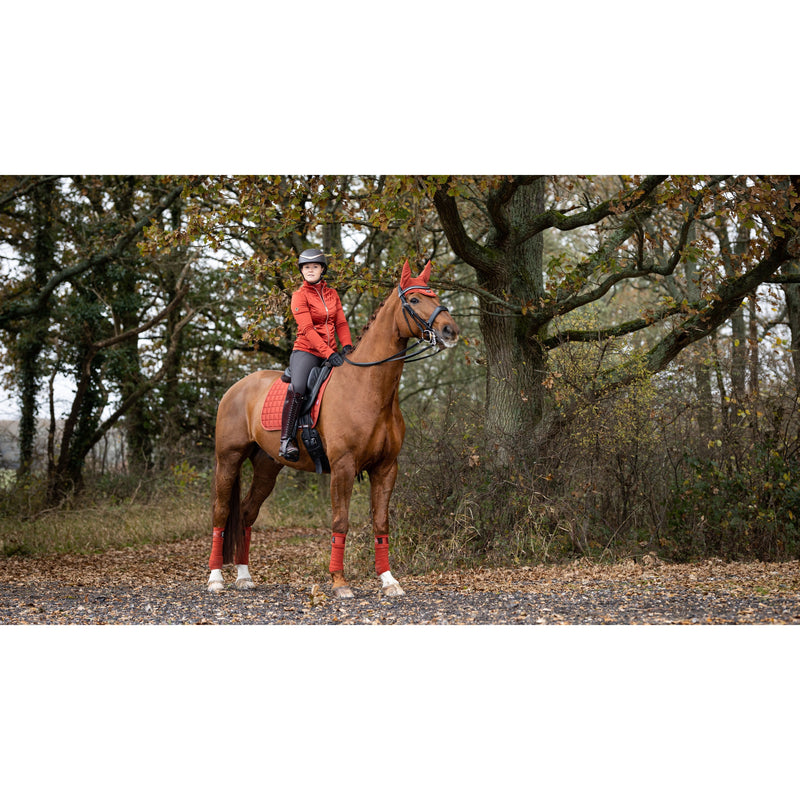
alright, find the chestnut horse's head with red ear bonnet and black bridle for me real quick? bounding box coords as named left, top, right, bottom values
left=397, top=261, right=459, bottom=350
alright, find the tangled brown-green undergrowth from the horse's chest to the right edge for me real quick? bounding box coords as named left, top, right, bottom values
left=393, top=368, right=800, bottom=571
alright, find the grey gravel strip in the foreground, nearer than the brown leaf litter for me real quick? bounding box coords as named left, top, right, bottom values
left=0, top=584, right=800, bottom=625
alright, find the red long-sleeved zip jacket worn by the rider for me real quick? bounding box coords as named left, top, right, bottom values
left=292, top=281, right=353, bottom=358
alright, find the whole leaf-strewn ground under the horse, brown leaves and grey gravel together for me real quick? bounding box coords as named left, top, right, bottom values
left=0, top=531, right=800, bottom=625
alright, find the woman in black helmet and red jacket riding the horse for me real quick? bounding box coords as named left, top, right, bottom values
left=278, top=249, right=353, bottom=461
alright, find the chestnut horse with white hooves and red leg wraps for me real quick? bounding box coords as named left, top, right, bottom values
left=208, top=261, right=459, bottom=597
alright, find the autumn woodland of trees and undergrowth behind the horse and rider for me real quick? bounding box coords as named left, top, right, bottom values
left=0, top=175, right=800, bottom=565
